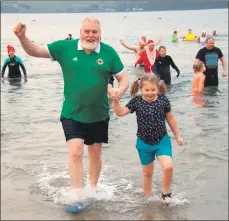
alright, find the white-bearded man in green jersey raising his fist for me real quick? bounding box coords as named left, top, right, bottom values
left=14, top=17, right=129, bottom=212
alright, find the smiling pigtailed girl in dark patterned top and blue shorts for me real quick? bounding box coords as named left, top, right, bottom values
left=113, top=73, right=183, bottom=203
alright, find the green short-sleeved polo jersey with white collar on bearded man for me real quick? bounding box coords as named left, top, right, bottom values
left=47, top=39, right=124, bottom=123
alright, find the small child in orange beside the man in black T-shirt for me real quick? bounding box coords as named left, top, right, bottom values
left=192, top=61, right=206, bottom=96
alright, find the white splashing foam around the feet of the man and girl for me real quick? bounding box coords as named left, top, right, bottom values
left=37, top=168, right=190, bottom=206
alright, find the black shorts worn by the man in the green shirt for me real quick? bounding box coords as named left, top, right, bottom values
left=60, top=117, right=110, bottom=145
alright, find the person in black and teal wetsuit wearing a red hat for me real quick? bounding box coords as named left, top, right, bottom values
left=2, top=45, right=27, bottom=78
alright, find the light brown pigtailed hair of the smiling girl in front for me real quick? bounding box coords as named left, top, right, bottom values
left=130, top=73, right=167, bottom=97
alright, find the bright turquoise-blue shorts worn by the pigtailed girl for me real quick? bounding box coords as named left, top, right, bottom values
left=136, top=134, right=172, bottom=165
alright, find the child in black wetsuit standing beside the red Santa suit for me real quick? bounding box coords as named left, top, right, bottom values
left=154, top=46, right=180, bottom=85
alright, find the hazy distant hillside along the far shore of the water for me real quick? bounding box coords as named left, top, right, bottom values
left=1, top=0, right=228, bottom=13
